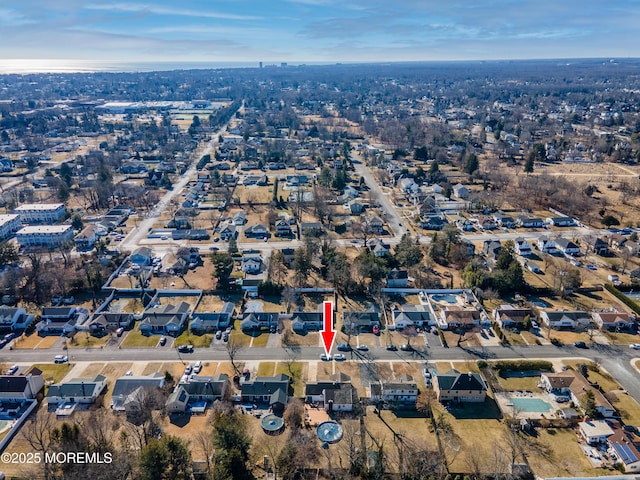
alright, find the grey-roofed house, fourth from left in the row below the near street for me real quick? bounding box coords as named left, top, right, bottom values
left=166, top=373, right=229, bottom=413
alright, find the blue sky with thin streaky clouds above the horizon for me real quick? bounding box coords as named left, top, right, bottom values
left=0, top=0, right=640, bottom=65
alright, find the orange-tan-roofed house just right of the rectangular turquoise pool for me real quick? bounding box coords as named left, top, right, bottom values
left=540, top=370, right=616, bottom=418
